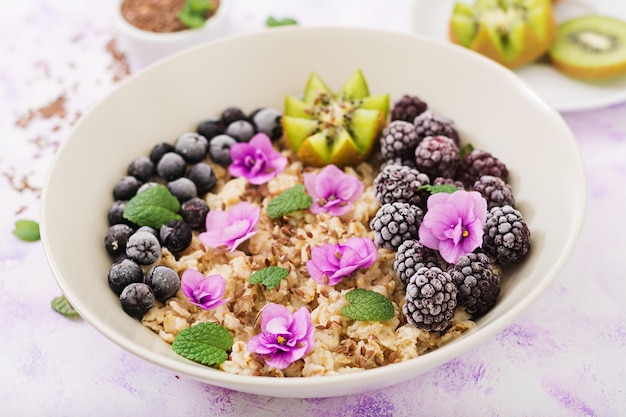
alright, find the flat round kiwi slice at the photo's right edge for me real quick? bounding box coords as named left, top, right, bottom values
left=548, top=15, right=626, bottom=80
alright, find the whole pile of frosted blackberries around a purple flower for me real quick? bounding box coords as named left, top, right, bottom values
left=378, top=95, right=530, bottom=331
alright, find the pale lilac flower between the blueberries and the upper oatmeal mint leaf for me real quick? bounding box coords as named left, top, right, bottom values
left=198, top=201, right=261, bottom=252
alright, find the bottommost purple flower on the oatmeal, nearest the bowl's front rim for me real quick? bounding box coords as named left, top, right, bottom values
left=247, top=303, right=315, bottom=369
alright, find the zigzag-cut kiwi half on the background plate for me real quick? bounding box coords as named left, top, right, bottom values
left=449, top=0, right=556, bottom=68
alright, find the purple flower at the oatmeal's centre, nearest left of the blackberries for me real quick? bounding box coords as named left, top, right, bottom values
left=306, top=237, right=378, bottom=285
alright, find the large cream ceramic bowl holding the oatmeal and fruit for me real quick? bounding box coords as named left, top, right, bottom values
left=41, top=28, right=586, bottom=397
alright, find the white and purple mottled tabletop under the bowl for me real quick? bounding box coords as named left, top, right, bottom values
left=0, top=0, right=626, bottom=417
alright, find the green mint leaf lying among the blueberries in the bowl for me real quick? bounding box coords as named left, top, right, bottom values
left=123, top=185, right=182, bottom=230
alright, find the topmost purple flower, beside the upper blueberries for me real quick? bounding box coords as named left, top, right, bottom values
left=228, top=133, right=287, bottom=185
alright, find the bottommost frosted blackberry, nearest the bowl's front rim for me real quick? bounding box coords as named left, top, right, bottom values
left=402, top=266, right=458, bottom=332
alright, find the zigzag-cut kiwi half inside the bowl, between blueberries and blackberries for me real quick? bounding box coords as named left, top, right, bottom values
left=282, top=70, right=389, bottom=167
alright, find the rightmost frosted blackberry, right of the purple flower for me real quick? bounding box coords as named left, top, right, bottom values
left=483, top=205, right=530, bottom=265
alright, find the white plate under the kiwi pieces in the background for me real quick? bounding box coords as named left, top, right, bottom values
left=412, top=0, right=626, bottom=112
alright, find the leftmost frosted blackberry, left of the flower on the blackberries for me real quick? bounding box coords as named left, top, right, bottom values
left=370, top=202, right=424, bottom=251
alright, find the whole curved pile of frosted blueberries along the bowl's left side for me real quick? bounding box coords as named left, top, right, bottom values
left=104, top=107, right=282, bottom=319
